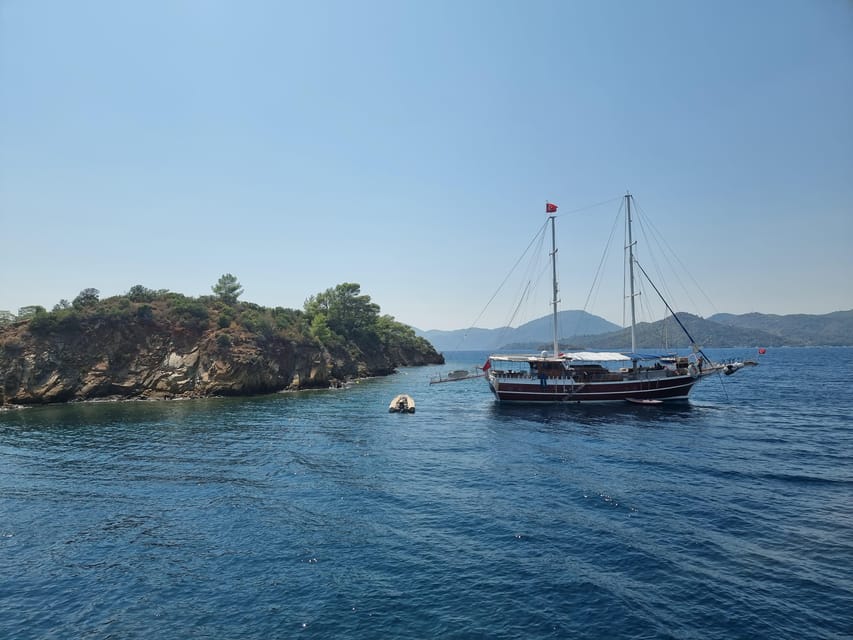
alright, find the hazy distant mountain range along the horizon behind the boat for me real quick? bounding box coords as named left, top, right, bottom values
left=415, top=309, right=853, bottom=351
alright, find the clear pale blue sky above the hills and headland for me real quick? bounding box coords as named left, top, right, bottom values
left=0, top=0, right=853, bottom=329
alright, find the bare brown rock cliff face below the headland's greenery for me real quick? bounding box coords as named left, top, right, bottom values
left=0, top=317, right=443, bottom=404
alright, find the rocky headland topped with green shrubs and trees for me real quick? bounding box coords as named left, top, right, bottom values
left=0, top=274, right=444, bottom=405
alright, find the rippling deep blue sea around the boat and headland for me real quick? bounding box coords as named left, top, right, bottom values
left=0, top=348, right=853, bottom=640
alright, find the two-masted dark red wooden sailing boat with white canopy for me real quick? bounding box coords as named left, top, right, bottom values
left=483, top=194, right=748, bottom=404
